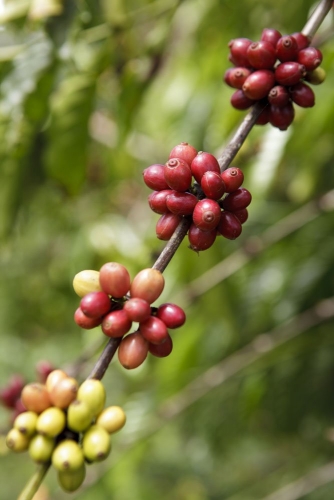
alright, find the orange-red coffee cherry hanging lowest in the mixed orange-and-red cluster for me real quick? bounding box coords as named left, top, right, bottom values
left=118, top=332, right=148, bottom=370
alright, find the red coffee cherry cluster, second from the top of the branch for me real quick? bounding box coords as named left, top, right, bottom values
left=143, top=142, right=252, bottom=252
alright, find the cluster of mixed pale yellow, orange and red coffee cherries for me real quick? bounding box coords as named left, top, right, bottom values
left=73, top=262, right=186, bottom=369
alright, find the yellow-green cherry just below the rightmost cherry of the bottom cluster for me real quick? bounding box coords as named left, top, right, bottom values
left=82, top=425, right=111, bottom=462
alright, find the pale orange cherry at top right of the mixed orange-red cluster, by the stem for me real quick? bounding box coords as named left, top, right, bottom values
left=130, top=268, right=165, bottom=304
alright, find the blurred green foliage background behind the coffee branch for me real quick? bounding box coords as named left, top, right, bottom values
left=0, top=0, right=334, bottom=500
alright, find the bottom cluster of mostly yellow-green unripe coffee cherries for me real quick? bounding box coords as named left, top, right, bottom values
left=6, top=369, right=126, bottom=491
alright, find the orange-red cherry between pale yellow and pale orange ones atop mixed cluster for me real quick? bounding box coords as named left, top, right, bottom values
left=100, top=262, right=130, bottom=298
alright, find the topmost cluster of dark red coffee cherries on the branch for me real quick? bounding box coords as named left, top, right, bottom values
left=224, top=28, right=325, bottom=130
